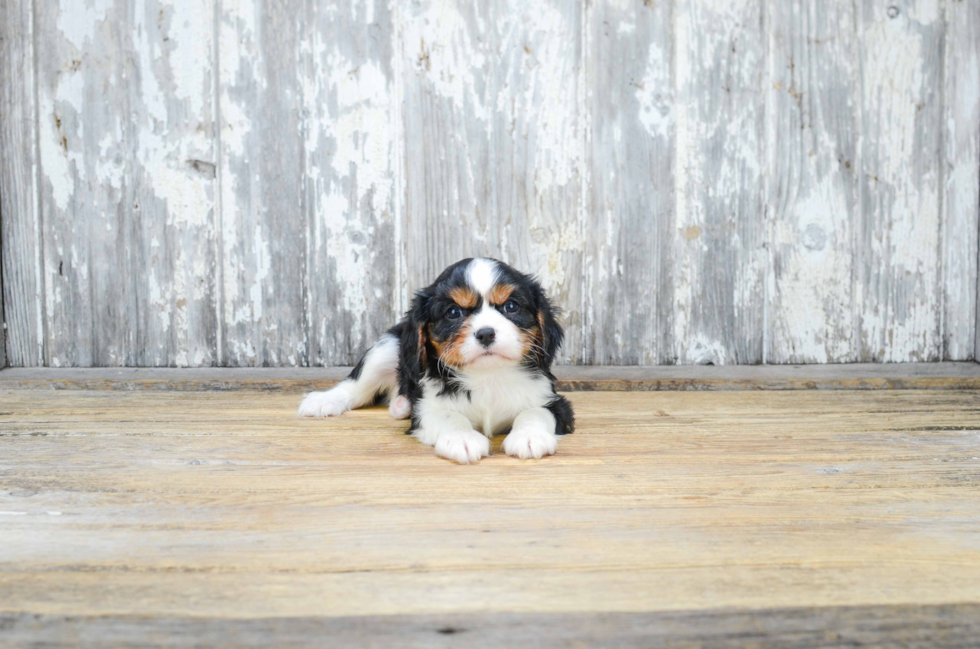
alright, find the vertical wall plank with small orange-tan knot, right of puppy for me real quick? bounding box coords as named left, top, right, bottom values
left=672, top=0, right=767, bottom=364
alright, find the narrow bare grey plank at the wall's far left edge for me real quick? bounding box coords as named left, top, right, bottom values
left=0, top=0, right=44, bottom=366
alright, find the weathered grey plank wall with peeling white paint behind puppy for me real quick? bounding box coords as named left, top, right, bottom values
left=0, top=0, right=980, bottom=366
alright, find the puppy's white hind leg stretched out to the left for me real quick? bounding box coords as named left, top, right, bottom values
left=297, top=332, right=398, bottom=417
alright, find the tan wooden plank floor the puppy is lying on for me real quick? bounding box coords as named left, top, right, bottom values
left=0, top=389, right=980, bottom=646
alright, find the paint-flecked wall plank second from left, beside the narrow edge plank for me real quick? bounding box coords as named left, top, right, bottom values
left=36, top=2, right=131, bottom=367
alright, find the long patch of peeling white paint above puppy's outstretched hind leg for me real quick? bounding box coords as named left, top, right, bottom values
left=301, top=12, right=394, bottom=344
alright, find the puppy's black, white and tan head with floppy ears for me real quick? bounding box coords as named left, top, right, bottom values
left=412, top=259, right=564, bottom=373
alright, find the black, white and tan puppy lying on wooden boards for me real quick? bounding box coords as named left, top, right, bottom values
left=299, top=259, right=575, bottom=464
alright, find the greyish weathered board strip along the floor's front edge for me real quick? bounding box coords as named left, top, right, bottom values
left=0, top=604, right=980, bottom=649
